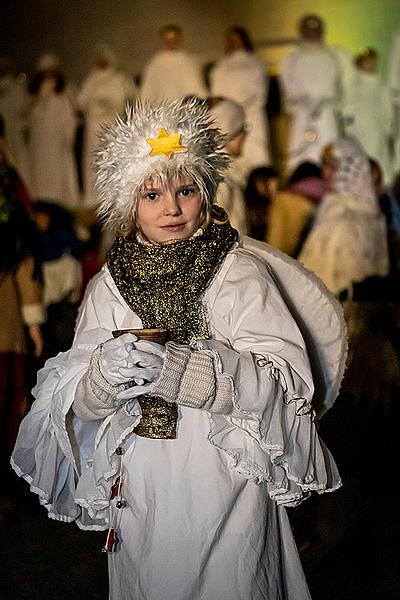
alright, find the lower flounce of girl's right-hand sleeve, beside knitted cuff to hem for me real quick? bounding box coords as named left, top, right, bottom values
left=198, top=340, right=341, bottom=506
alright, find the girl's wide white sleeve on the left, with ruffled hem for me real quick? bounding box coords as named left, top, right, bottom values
left=11, top=271, right=140, bottom=529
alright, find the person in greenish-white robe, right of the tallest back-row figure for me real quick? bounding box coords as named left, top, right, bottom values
left=343, top=48, right=393, bottom=183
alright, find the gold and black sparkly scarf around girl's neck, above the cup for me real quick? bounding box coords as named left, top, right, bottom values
left=107, top=218, right=238, bottom=343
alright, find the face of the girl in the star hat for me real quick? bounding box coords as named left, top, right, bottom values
left=136, top=177, right=203, bottom=244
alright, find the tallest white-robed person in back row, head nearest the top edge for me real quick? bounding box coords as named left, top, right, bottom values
left=280, top=15, right=341, bottom=172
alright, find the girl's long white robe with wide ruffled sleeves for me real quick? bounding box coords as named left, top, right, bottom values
left=12, top=240, right=340, bottom=600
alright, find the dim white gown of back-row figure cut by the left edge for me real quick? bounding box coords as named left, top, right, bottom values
left=0, top=58, right=27, bottom=179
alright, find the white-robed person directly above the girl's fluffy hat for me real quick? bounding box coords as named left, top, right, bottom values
left=140, top=25, right=207, bottom=100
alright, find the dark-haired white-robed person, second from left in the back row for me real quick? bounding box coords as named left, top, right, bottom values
left=27, top=54, right=80, bottom=208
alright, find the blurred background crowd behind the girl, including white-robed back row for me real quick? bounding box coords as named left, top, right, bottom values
left=0, top=15, right=400, bottom=524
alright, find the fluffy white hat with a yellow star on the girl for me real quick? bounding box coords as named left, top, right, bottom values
left=95, top=98, right=229, bottom=230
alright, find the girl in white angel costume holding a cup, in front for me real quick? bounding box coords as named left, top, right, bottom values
left=12, top=100, right=344, bottom=600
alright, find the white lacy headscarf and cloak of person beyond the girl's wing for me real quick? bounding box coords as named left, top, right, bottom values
left=299, top=138, right=389, bottom=294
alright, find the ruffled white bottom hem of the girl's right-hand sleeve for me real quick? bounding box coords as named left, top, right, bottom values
left=208, top=382, right=342, bottom=506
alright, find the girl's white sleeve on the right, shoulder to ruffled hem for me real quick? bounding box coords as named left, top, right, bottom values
left=203, top=256, right=341, bottom=505
